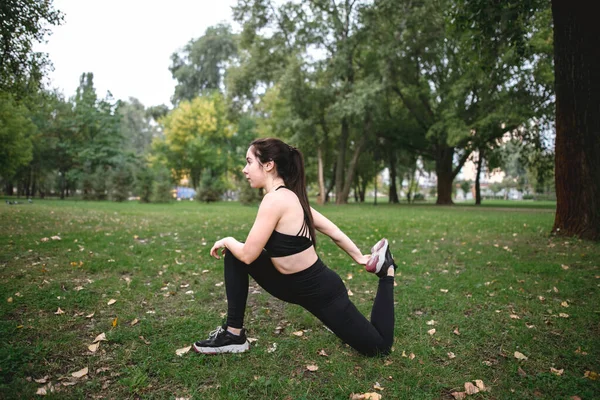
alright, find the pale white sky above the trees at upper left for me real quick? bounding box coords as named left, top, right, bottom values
left=35, top=0, right=237, bottom=107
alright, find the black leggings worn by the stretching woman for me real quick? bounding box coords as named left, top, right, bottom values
left=225, top=251, right=394, bottom=356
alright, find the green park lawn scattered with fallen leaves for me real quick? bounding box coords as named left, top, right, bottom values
left=0, top=200, right=600, bottom=399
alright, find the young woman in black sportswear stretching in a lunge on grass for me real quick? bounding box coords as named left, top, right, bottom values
left=194, top=138, right=396, bottom=356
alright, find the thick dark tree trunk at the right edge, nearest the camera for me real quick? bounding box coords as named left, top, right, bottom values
left=552, top=0, right=600, bottom=240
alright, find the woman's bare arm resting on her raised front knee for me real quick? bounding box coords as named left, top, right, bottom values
left=210, top=194, right=282, bottom=264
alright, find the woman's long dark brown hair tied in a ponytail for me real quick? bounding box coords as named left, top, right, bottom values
left=250, top=138, right=317, bottom=247
